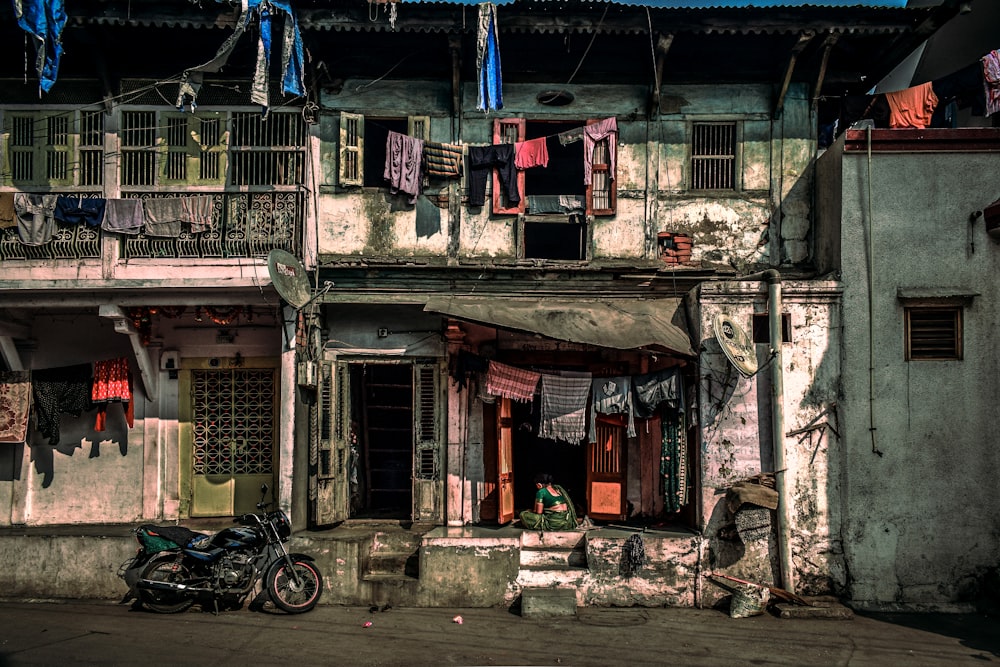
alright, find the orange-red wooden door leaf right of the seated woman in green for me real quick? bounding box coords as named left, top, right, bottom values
left=587, top=415, right=626, bottom=521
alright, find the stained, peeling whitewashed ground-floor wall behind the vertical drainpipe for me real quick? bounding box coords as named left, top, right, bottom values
left=693, top=281, right=845, bottom=594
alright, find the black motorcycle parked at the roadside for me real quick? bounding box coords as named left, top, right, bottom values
left=118, top=484, right=323, bottom=614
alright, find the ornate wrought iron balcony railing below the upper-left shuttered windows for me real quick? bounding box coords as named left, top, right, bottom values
left=0, top=191, right=305, bottom=262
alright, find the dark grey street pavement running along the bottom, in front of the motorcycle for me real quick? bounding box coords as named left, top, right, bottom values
left=0, top=602, right=1000, bottom=667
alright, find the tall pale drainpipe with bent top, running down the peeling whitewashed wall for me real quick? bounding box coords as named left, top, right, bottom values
left=743, top=269, right=795, bottom=593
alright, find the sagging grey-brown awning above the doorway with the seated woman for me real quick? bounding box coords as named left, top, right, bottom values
left=424, top=296, right=695, bottom=357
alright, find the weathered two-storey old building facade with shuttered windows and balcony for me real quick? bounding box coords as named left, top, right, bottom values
left=0, top=1, right=984, bottom=605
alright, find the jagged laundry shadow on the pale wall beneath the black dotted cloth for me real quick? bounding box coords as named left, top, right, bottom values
left=27, top=406, right=128, bottom=489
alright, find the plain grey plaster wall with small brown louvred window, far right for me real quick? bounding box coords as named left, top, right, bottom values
left=841, top=141, right=1000, bottom=606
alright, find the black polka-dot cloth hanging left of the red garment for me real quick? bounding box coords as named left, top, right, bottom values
left=31, top=364, right=94, bottom=446
